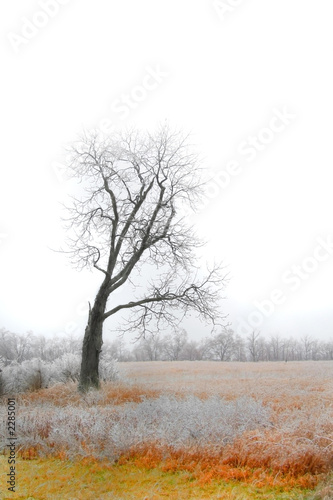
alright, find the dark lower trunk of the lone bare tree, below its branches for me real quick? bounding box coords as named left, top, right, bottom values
left=78, top=283, right=108, bottom=392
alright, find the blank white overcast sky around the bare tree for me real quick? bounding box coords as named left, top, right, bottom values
left=0, top=0, right=333, bottom=339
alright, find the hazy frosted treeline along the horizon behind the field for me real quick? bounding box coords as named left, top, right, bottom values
left=0, top=328, right=333, bottom=367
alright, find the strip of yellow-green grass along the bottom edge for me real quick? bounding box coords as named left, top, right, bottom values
left=0, top=456, right=322, bottom=500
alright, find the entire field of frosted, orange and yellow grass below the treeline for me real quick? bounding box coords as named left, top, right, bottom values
left=1, top=361, right=333, bottom=500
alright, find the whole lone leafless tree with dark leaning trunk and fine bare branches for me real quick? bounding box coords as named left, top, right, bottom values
left=65, top=126, right=224, bottom=392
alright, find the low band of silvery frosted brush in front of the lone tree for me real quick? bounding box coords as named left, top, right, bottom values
left=1, top=395, right=269, bottom=459
